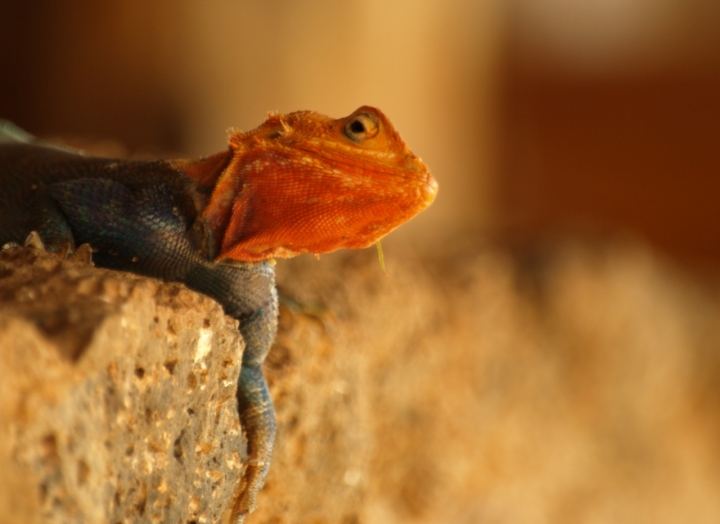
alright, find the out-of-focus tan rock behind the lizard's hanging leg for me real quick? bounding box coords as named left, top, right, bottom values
left=268, top=242, right=720, bottom=524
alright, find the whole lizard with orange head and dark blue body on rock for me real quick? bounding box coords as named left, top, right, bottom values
left=0, top=106, right=438, bottom=523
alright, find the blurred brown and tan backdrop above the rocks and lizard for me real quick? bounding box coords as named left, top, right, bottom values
left=0, top=0, right=720, bottom=264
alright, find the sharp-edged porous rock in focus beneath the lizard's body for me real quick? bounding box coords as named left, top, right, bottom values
left=0, top=248, right=245, bottom=523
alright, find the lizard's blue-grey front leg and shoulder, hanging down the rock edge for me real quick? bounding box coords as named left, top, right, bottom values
left=47, top=179, right=278, bottom=522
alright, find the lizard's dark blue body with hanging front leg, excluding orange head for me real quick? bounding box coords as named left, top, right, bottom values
left=0, top=135, right=278, bottom=514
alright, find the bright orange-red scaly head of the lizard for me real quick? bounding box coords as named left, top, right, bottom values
left=203, top=106, right=437, bottom=261
